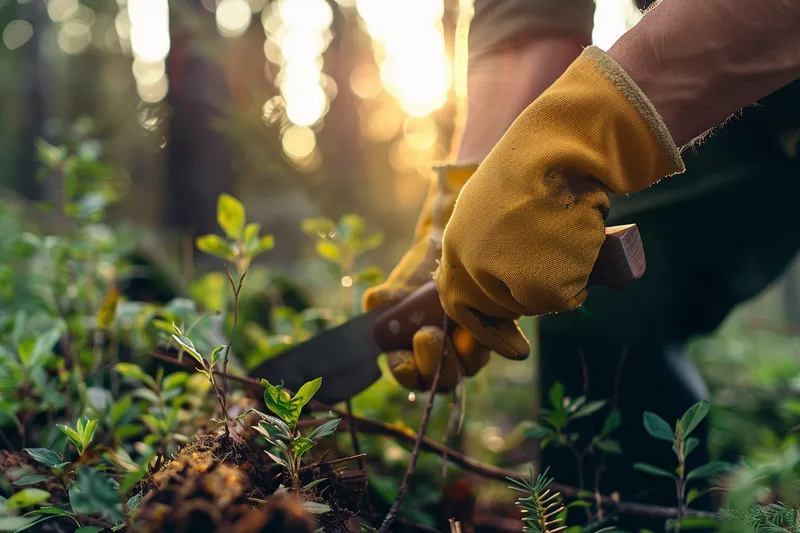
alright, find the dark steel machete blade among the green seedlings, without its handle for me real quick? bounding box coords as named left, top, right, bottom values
left=250, top=310, right=381, bottom=404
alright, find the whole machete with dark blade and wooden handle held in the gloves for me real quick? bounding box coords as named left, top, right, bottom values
left=249, top=224, right=646, bottom=405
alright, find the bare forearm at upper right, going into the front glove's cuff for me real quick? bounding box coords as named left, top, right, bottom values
left=609, top=0, right=800, bottom=146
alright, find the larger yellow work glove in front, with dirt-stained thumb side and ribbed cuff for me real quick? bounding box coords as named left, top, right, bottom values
left=435, top=47, right=684, bottom=359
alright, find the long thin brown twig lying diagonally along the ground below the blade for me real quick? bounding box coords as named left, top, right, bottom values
left=142, top=352, right=717, bottom=520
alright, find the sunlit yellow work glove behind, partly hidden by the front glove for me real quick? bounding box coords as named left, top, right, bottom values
left=363, top=165, right=489, bottom=391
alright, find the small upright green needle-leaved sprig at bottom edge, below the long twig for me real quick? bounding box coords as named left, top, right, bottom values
left=506, top=466, right=567, bottom=533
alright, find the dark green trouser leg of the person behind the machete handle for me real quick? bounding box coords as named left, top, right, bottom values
left=539, top=83, right=800, bottom=531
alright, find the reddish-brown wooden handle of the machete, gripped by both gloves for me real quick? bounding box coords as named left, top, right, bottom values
left=374, top=224, right=646, bottom=351
